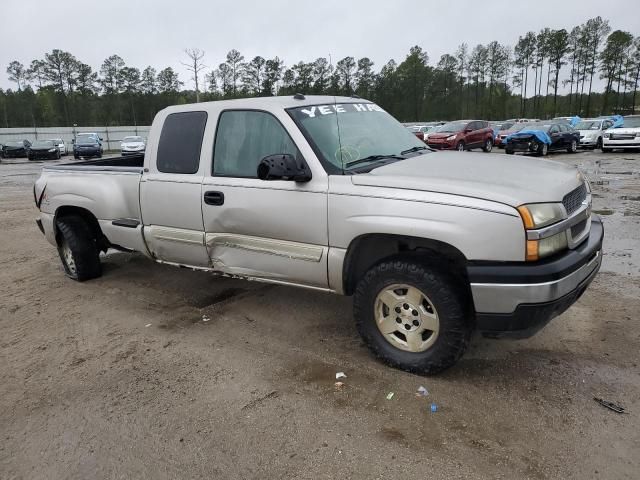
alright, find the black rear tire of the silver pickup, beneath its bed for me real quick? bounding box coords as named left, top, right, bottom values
left=57, top=215, right=102, bottom=282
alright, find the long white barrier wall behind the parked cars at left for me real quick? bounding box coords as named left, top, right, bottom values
left=0, top=126, right=151, bottom=150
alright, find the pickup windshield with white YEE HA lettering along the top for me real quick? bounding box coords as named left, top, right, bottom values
left=288, top=103, right=426, bottom=173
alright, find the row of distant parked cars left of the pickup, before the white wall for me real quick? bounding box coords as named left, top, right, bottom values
left=0, top=132, right=146, bottom=160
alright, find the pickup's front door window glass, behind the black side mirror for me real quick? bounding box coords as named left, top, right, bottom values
left=213, top=110, right=300, bottom=178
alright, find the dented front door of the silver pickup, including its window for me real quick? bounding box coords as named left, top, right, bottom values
left=202, top=109, right=328, bottom=288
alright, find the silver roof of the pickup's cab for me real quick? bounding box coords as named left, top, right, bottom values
left=158, top=95, right=371, bottom=113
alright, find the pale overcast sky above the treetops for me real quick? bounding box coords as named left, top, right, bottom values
left=0, top=0, right=640, bottom=88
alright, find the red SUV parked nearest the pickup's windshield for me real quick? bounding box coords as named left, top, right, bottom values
left=427, top=120, right=493, bottom=152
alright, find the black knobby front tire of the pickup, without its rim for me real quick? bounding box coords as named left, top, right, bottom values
left=353, top=257, right=473, bottom=375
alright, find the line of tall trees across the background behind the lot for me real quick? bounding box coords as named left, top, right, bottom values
left=0, top=17, right=640, bottom=127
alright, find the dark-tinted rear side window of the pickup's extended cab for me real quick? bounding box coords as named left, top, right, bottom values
left=156, top=112, right=207, bottom=174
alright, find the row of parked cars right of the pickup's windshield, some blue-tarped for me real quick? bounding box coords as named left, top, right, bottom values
left=406, top=115, right=640, bottom=156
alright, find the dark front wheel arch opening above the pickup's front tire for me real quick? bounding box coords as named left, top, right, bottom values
left=342, top=233, right=470, bottom=295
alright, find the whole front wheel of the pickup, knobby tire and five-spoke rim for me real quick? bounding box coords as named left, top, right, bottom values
left=353, top=258, right=472, bottom=374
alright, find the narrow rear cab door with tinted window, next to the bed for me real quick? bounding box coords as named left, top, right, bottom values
left=140, top=111, right=211, bottom=267
